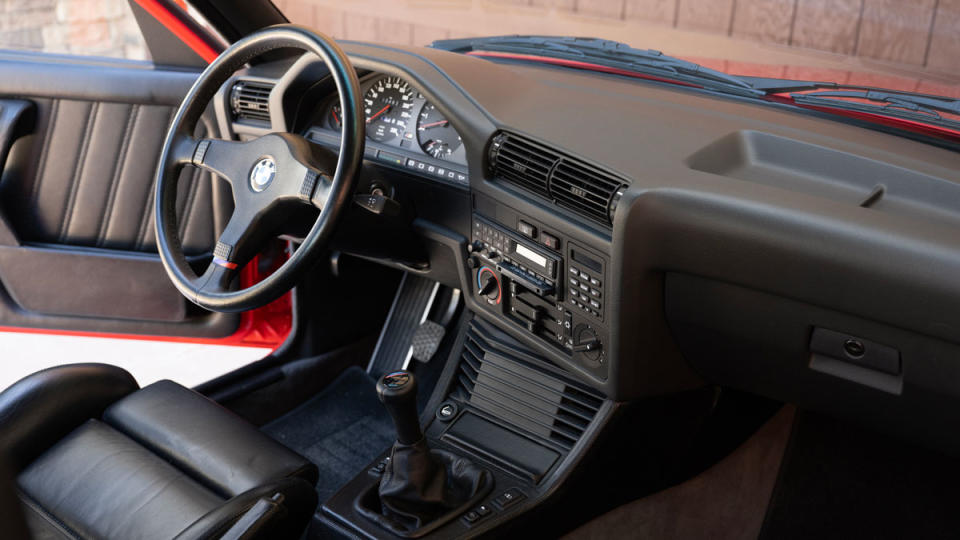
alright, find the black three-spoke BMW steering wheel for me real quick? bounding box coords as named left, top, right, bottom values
left=154, top=24, right=364, bottom=312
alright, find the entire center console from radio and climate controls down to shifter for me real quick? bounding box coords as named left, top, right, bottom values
left=320, top=178, right=617, bottom=538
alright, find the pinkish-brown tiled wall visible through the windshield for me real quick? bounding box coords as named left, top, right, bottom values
left=276, top=0, right=960, bottom=74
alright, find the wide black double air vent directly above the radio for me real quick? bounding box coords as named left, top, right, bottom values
left=490, top=133, right=630, bottom=225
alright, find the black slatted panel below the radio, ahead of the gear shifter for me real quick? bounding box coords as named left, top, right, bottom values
left=451, top=324, right=603, bottom=450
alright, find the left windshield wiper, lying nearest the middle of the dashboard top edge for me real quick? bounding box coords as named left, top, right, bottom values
left=430, top=36, right=767, bottom=97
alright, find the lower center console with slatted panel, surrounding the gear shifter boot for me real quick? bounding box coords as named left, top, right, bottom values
left=320, top=318, right=615, bottom=538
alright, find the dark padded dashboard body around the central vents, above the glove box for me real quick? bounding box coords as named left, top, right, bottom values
left=231, top=42, right=960, bottom=398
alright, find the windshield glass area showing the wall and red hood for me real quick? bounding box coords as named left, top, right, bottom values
left=277, top=0, right=960, bottom=137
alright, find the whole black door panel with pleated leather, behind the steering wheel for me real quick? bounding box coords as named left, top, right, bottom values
left=0, top=53, right=238, bottom=338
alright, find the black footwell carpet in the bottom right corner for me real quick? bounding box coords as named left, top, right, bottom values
left=761, top=412, right=960, bottom=540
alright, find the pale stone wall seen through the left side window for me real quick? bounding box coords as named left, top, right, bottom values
left=0, top=0, right=147, bottom=59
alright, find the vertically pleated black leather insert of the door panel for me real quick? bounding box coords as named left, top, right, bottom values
left=6, top=99, right=216, bottom=254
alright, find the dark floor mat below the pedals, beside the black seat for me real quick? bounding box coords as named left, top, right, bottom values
left=262, top=367, right=396, bottom=502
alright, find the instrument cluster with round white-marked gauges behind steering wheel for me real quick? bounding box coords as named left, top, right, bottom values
left=306, top=73, right=470, bottom=187
